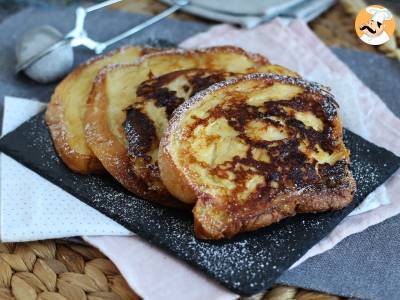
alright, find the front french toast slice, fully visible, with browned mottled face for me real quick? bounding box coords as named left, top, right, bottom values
left=158, top=74, right=355, bottom=239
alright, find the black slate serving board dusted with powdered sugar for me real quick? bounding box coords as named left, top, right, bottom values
left=0, top=113, right=400, bottom=295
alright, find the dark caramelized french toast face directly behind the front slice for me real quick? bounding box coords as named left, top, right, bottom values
left=124, top=65, right=294, bottom=202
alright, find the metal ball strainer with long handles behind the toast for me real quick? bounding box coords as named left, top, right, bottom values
left=16, top=0, right=190, bottom=83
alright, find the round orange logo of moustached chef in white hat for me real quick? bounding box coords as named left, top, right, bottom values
left=354, top=5, right=396, bottom=45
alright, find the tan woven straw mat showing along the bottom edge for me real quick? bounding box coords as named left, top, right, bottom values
left=0, top=240, right=342, bottom=300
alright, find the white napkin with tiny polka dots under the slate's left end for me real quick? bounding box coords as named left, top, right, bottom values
left=0, top=97, right=130, bottom=241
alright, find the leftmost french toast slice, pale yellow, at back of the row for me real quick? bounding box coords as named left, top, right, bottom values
left=46, top=46, right=155, bottom=174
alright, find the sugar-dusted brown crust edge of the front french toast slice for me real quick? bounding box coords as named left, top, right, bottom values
left=159, top=74, right=356, bottom=240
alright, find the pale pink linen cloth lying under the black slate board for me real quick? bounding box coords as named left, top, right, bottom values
left=85, top=19, right=400, bottom=299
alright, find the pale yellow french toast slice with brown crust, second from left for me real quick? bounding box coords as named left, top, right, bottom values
left=85, top=47, right=268, bottom=203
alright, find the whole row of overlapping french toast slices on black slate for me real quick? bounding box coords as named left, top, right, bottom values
left=46, top=46, right=355, bottom=239
